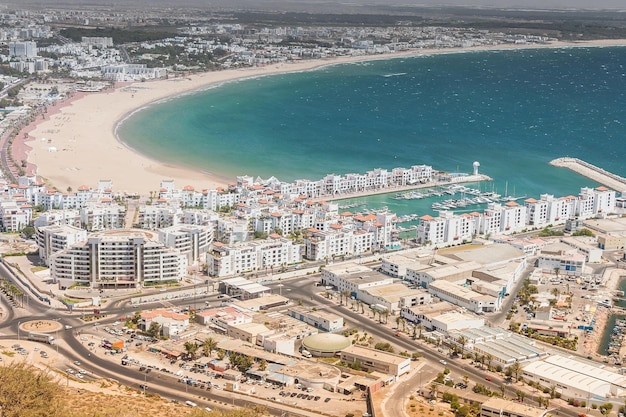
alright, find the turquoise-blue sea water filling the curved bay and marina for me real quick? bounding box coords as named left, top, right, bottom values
left=118, top=47, right=626, bottom=215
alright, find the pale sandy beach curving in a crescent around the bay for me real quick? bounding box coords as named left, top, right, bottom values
left=22, top=40, right=626, bottom=195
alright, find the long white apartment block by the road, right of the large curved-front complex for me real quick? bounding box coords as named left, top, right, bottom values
left=206, top=235, right=302, bottom=277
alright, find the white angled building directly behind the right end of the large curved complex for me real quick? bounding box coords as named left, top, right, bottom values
left=159, top=224, right=213, bottom=265
